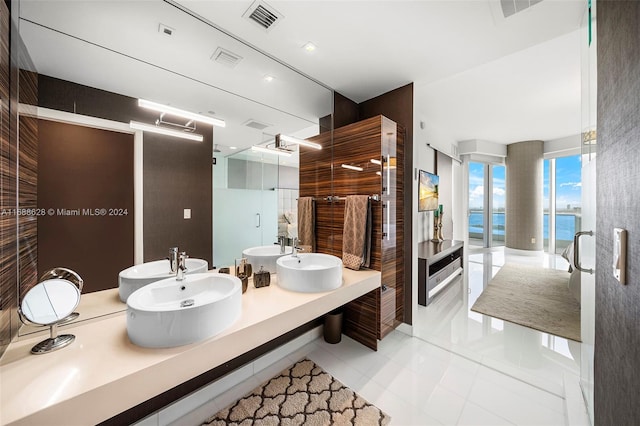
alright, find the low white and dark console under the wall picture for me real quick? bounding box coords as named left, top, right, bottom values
left=418, top=240, right=464, bottom=306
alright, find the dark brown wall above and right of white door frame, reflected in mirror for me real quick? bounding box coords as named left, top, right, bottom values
left=39, top=75, right=213, bottom=265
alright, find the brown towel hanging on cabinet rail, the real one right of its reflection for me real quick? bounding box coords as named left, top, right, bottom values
left=342, top=195, right=372, bottom=271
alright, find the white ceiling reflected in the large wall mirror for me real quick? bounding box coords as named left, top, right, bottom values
left=20, top=0, right=332, bottom=155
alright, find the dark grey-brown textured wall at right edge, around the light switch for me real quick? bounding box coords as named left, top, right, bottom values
left=596, top=1, right=640, bottom=426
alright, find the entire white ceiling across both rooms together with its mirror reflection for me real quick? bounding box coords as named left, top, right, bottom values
left=20, top=0, right=586, bottom=146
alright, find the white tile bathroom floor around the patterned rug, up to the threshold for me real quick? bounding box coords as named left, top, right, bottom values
left=176, top=331, right=566, bottom=426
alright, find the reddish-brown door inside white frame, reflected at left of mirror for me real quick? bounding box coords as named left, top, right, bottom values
left=36, top=120, right=134, bottom=293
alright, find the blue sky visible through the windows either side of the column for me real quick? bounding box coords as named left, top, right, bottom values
left=469, top=155, right=582, bottom=211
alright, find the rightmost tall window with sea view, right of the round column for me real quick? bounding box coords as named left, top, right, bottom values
left=544, top=155, right=582, bottom=253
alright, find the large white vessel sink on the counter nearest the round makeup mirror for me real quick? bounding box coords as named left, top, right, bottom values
left=127, top=272, right=242, bottom=348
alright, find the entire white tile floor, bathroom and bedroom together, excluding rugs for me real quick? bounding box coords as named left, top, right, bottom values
left=159, top=248, right=588, bottom=426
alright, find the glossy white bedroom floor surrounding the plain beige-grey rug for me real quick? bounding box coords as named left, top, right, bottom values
left=413, top=246, right=580, bottom=397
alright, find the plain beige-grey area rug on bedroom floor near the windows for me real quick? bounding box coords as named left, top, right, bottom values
left=471, top=263, right=581, bottom=342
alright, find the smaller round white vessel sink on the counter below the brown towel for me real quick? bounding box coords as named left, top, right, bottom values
left=276, top=253, right=342, bottom=293
